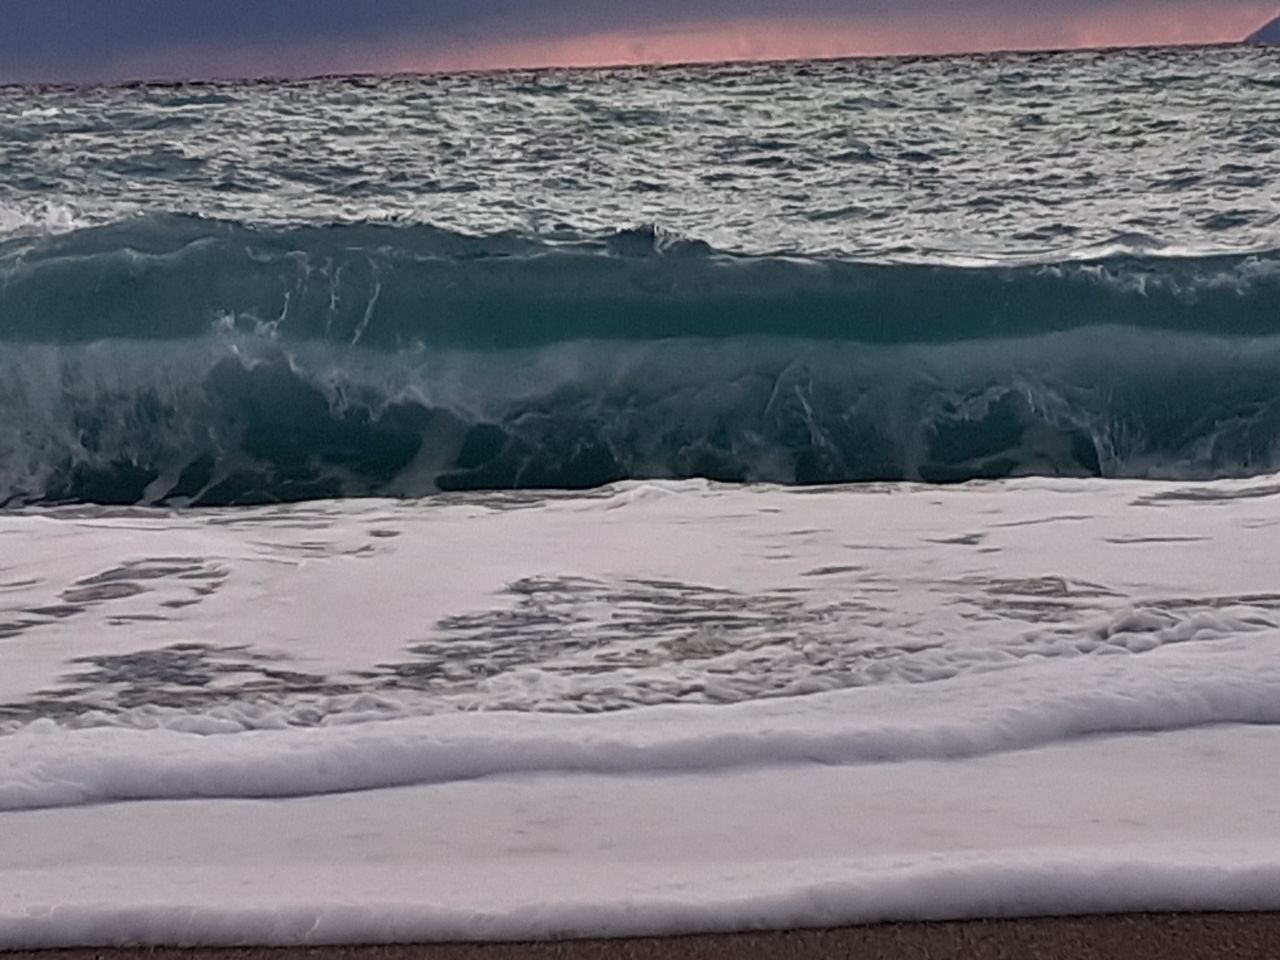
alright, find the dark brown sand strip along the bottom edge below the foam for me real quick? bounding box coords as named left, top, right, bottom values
left=0, top=914, right=1280, bottom=960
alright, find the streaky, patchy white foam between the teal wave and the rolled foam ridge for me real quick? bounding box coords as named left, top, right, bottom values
left=0, top=479, right=1280, bottom=730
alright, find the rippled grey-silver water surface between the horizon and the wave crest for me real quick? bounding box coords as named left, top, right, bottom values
left=0, top=47, right=1280, bottom=260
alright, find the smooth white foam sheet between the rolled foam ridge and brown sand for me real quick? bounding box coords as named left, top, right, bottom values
left=0, top=727, right=1280, bottom=947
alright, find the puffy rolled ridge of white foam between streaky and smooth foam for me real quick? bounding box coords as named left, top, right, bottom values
left=0, top=631, right=1280, bottom=810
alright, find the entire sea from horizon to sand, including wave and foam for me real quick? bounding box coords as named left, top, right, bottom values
left=0, top=46, right=1280, bottom=947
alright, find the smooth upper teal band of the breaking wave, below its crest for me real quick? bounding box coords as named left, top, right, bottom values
left=0, top=215, right=1280, bottom=349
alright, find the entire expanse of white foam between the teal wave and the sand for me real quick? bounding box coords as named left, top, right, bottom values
left=0, top=477, right=1280, bottom=947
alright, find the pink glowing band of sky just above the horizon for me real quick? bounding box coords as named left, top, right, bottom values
left=394, top=0, right=1276, bottom=70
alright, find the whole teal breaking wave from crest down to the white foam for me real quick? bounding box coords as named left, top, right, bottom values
left=0, top=215, right=1280, bottom=506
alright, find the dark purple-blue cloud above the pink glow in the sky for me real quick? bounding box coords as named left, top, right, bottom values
left=0, top=0, right=1259, bottom=81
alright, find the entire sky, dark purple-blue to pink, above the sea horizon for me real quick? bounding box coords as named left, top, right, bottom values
left=0, top=0, right=1280, bottom=83
